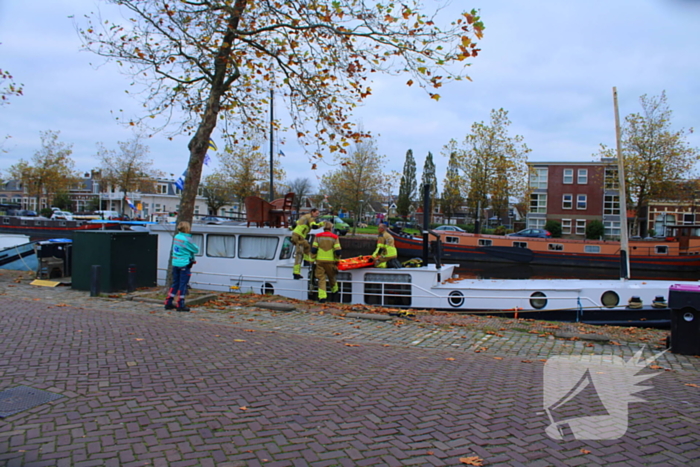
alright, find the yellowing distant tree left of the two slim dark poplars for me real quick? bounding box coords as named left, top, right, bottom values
left=321, top=139, right=385, bottom=233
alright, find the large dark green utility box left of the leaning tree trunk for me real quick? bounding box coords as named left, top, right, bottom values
left=72, top=230, right=158, bottom=292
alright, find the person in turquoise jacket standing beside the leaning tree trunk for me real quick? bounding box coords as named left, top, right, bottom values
left=165, top=221, right=199, bottom=311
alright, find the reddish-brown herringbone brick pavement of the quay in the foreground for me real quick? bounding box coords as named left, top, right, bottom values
left=0, top=276, right=700, bottom=467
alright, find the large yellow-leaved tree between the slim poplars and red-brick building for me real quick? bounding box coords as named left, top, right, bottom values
left=448, top=109, right=530, bottom=224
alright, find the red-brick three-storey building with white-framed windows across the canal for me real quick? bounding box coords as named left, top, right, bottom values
left=526, top=159, right=621, bottom=239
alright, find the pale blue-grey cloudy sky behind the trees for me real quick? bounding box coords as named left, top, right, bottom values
left=0, top=0, right=700, bottom=191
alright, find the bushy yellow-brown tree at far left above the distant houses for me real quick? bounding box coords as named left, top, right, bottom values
left=9, top=130, right=76, bottom=208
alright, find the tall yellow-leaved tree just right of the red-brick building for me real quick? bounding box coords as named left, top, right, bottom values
left=598, top=92, right=700, bottom=234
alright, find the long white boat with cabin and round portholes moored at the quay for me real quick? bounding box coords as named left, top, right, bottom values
left=150, top=225, right=698, bottom=317
